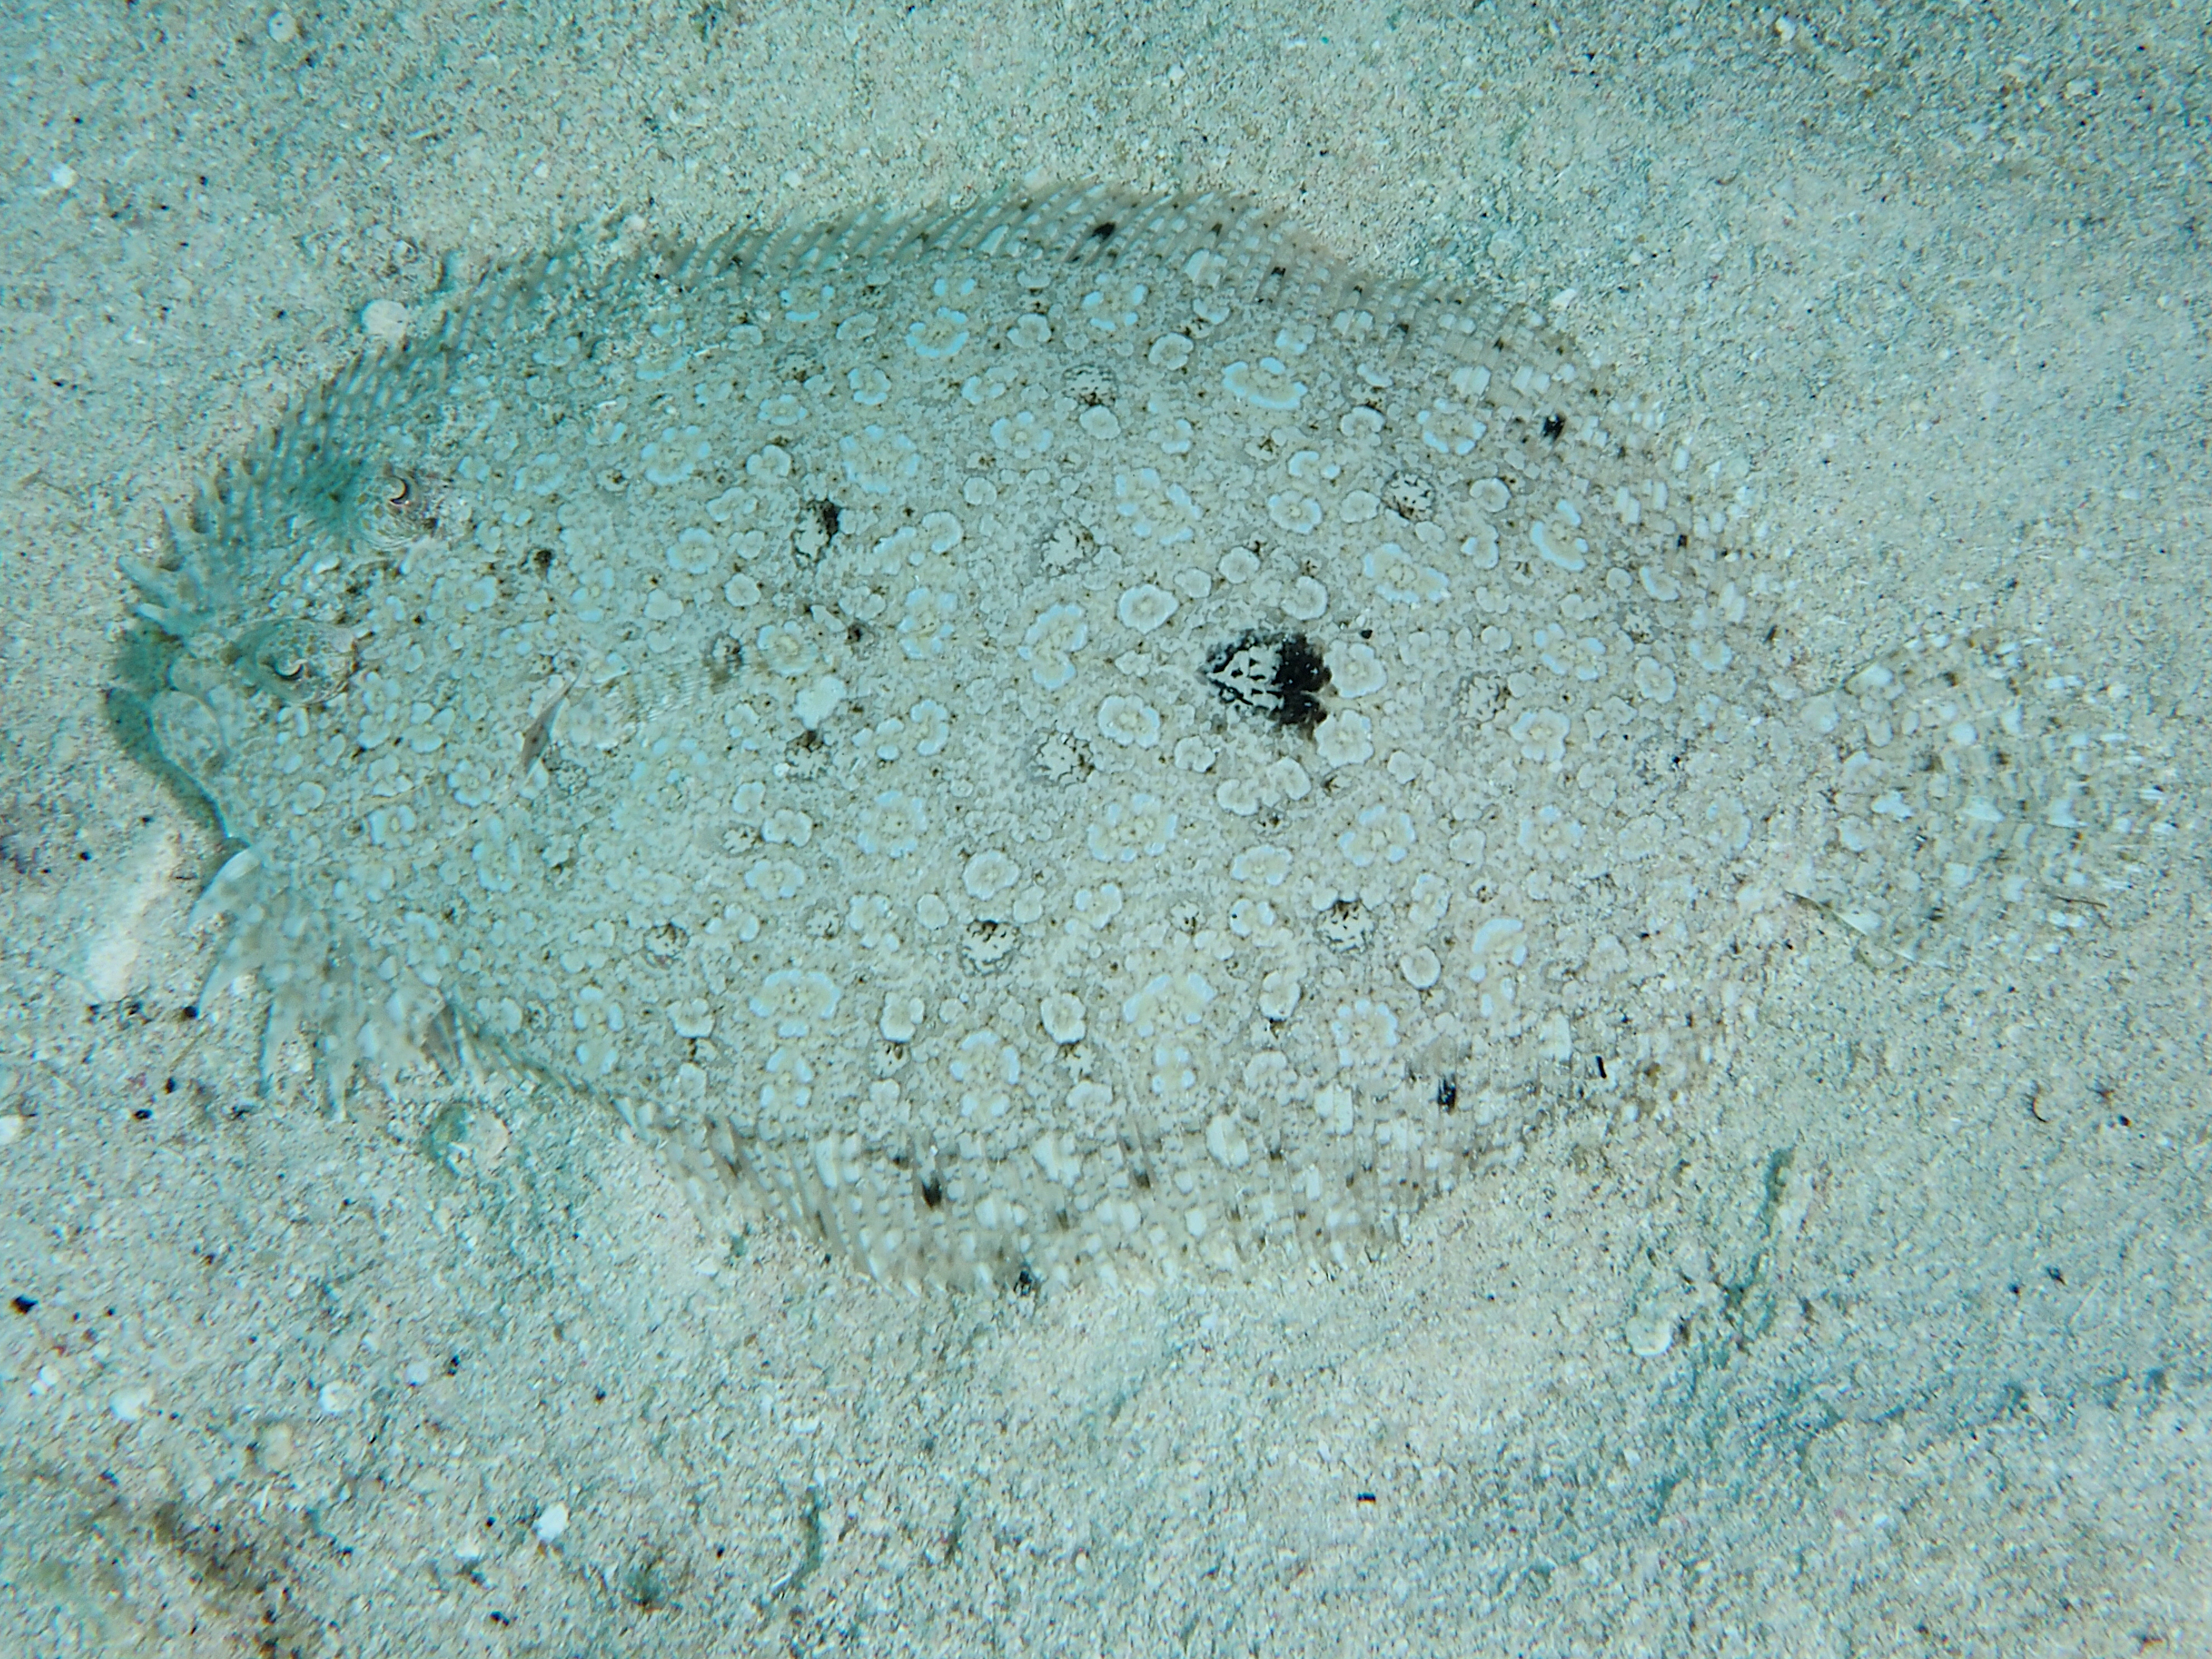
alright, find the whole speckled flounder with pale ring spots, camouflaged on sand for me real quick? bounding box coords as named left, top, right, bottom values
left=133, top=190, right=2163, bottom=1283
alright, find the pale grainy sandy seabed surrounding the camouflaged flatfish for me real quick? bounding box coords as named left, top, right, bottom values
left=0, top=0, right=2212, bottom=1655
